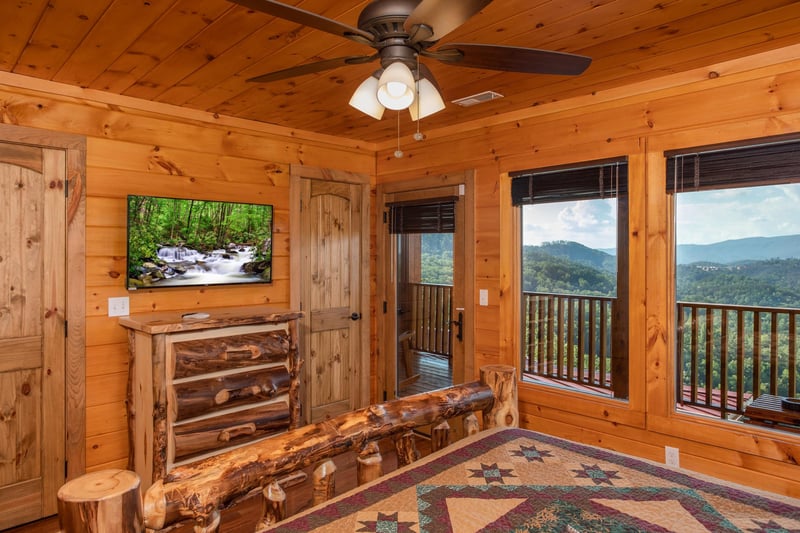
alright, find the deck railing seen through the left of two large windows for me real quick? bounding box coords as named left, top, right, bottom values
left=522, top=292, right=614, bottom=389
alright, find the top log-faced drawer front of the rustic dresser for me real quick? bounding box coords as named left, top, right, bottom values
left=172, top=330, right=291, bottom=379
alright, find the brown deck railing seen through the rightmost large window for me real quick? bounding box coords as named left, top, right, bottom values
left=676, top=302, right=800, bottom=418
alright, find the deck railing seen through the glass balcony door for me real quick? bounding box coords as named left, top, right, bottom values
left=409, top=283, right=453, bottom=357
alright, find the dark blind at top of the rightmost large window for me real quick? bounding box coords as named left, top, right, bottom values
left=665, top=139, right=800, bottom=192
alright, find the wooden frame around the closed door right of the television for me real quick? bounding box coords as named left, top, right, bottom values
left=289, top=164, right=372, bottom=423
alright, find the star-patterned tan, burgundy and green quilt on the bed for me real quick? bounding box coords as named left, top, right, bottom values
left=273, top=429, right=800, bottom=533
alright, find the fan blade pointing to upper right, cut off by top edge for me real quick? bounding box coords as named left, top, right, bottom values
left=403, top=0, right=492, bottom=43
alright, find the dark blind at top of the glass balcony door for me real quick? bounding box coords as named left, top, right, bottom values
left=387, top=196, right=458, bottom=234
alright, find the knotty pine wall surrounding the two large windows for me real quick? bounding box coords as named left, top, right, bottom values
left=377, top=46, right=800, bottom=497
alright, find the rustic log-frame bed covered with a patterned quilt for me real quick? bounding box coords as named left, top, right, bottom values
left=59, top=365, right=800, bottom=533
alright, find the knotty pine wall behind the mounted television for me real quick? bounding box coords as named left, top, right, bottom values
left=0, top=74, right=375, bottom=471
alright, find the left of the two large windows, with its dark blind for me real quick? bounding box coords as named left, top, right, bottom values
left=511, top=159, right=628, bottom=399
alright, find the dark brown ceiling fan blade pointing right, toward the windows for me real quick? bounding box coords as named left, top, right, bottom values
left=434, top=43, right=592, bottom=76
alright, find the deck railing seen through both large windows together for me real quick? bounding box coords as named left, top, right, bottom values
left=522, top=292, right=800, bottom=418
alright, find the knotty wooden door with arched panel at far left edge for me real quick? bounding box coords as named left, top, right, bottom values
left=0, top=144, right=66, bottom=529
